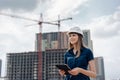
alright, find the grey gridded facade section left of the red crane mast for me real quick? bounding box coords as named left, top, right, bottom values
left=6, top=52, right=38, bottom=80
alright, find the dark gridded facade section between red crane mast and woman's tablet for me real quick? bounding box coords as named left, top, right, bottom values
left=42, top=49, right=66, bottom=80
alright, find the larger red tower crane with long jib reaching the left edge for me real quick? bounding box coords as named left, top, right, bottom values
left=0, top=13, right=58, bottom=80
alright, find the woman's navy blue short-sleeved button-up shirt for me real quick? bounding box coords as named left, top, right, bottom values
left=64, top=48, right=94, bottom=80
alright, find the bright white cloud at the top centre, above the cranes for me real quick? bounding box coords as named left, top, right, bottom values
left=45, top=0, right=88, bottom=18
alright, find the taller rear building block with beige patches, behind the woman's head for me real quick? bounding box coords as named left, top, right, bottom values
left=35, top=30, right=93, bottom=51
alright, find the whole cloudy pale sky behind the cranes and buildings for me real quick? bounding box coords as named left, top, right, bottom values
left=0, top=0, right=120, bottom=80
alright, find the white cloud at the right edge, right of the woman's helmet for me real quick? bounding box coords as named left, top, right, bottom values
left=87, top=11, right=120, bottom=38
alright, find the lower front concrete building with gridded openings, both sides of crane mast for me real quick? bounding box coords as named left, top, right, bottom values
left=6, top=49, right=66, bottom=80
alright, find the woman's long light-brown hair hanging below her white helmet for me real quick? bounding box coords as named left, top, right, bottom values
left=68, top=33, right=85, bottom=57
